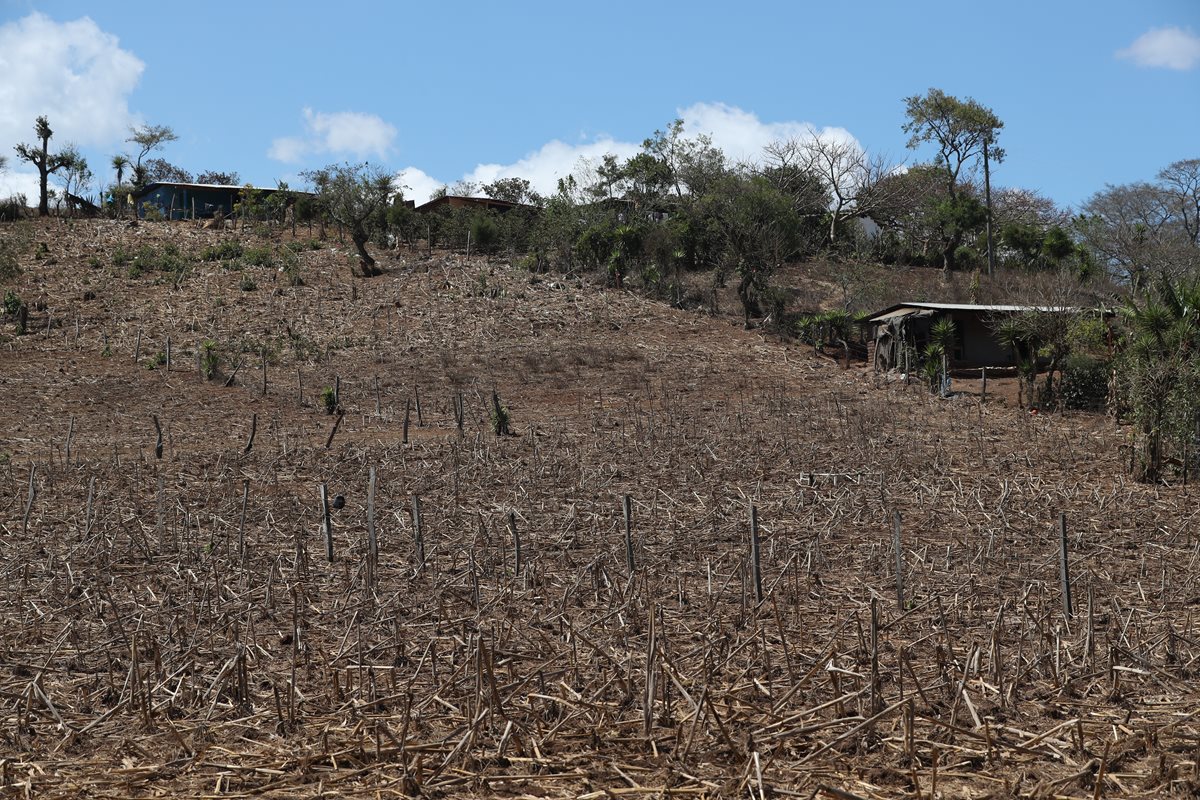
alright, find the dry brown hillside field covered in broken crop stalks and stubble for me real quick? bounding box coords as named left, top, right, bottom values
left=0, top=215, right=1200, bottom=800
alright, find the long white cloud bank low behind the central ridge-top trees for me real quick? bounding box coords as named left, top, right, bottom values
left=400, top=103, right=858, bottom=204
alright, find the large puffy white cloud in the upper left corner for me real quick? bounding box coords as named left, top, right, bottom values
left=0, top=12, right=145, bottom=151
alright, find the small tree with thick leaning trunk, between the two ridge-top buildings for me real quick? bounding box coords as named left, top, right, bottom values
left=304, top=163, right=396, bottom=277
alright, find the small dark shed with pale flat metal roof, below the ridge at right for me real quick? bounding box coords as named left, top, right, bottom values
left=866, top=302, right=1074, bottom=372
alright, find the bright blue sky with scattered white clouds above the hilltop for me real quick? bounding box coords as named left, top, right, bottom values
left=0, top=0, right=1200, bottom=205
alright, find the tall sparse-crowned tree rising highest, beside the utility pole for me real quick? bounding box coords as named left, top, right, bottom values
left=902, top=89, right=1004, bottom=279
